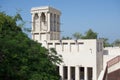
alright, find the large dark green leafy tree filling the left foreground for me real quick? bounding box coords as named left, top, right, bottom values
left=0, top=12, right=62, bottom=80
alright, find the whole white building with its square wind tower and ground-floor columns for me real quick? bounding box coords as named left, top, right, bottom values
left=31, top=6, right=119, bottom=80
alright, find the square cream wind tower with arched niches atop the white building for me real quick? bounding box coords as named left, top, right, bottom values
left=31, top=6, right=61, bottom=41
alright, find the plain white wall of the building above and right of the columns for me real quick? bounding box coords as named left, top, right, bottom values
left=43, top=39, right=103, bottom=80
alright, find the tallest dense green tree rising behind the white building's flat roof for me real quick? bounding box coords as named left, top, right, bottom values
left=82, top=29, right=97, bottom=39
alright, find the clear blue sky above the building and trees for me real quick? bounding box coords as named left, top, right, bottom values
left=0, top=0, right=120, bottom=42
